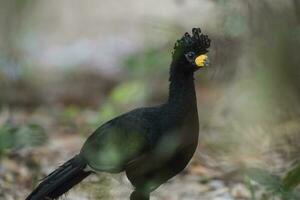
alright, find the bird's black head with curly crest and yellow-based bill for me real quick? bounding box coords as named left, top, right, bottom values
left=173, top=28, right=210, bottom=71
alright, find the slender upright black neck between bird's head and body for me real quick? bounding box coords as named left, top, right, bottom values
left=168, top=63, right=197, bottom=111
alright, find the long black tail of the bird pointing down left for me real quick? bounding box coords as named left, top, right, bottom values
left=26, top=155, right=92, bottom=200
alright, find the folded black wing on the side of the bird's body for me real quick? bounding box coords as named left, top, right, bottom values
left=81, top=112, right=151, bottom=172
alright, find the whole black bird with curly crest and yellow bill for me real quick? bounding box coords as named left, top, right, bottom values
left=26, top=28, right=210, bottom=200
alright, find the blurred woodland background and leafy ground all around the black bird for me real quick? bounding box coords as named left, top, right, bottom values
left=0, top=0, right=300, bottom=200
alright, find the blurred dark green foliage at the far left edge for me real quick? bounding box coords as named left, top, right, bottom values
left=0, top=123, right=46, bottom=154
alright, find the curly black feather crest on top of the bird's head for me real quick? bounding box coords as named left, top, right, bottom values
left=173, top=28, right=211, bottom=55
